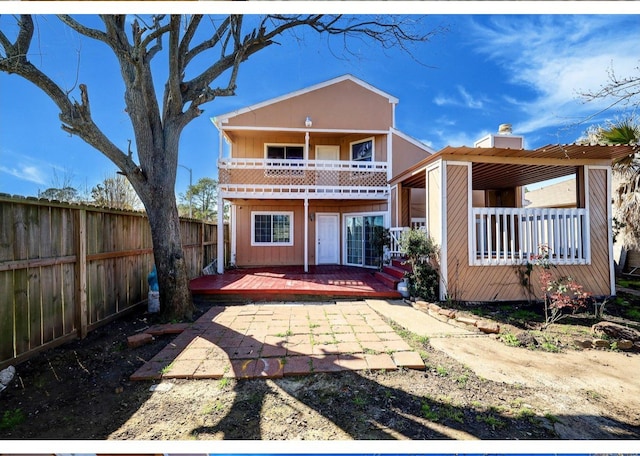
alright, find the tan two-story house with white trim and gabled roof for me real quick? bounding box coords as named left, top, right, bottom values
left=213, top=75, right=433, bottom=273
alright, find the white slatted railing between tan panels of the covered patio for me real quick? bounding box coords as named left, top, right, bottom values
left=469, top=208, right=590, bottom=266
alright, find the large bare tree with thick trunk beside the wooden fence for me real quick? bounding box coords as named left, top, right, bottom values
left=0, top=14, right=440, bottom=319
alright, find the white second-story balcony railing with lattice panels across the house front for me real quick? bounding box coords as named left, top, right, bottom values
left=218, top=158, right=389, bottom=199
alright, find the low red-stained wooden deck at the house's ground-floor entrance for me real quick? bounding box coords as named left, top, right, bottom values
left=190, top=266, right=400, bottom=303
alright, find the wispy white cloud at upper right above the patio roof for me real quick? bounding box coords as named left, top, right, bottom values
left=471, top=15, right=640, bottom=133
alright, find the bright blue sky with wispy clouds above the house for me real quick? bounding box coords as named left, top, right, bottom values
left=0, top=10, right=640, bottom=196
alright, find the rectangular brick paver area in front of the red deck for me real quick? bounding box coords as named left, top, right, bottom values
left=131, top=302, right=425, bottom=380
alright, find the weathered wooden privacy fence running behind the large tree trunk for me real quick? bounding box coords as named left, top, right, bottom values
left=0, top=195, right=228, bottom=369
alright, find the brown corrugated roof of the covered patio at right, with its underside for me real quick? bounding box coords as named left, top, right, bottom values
left=390, top=144, right=634, bottom=190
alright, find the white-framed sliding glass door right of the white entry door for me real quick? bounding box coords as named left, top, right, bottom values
left=345, top=215, right=384, bottom=266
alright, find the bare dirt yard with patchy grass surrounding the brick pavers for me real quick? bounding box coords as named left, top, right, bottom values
left=0, top=298, right=640, bottom=440
